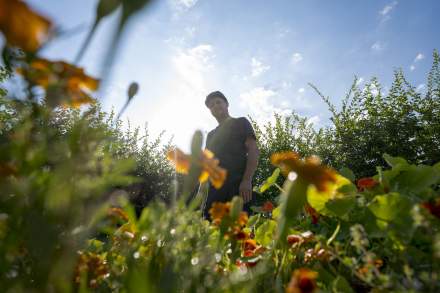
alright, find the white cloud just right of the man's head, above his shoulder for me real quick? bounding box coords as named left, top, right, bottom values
left=239, top=87, right=291, bottom=123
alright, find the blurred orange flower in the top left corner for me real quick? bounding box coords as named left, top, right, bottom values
left=0, top=0, right=52, bottom=52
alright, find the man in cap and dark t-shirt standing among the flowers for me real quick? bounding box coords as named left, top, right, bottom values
left=203, top=91, right=259, bottom=218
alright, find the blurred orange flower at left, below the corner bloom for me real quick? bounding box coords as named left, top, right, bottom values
left=18, top=58, right=99, bottom=107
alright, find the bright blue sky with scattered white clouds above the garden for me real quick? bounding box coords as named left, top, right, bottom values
left=8, top=0, right=440, bottom=150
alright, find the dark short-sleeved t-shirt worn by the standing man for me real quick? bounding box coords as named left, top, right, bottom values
left=206, top=117, right=255, bottom=181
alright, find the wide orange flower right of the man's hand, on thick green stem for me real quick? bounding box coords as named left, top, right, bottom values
left=270, top=152, right=336, bottom=191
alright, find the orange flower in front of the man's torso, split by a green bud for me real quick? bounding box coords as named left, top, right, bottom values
left=167, top=149, right=226, bottom=189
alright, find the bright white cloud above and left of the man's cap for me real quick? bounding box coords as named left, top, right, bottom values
left=172, top=44, right=214, bottom=89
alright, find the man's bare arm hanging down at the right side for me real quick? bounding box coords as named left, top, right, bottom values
left=240, top=137, right=260, bottom=203
